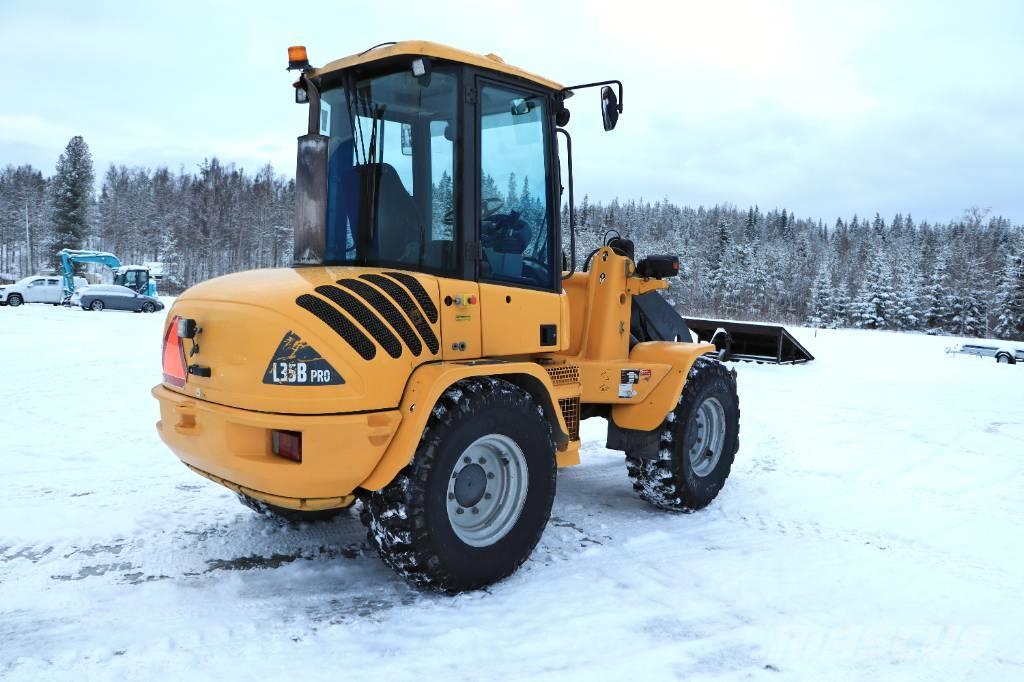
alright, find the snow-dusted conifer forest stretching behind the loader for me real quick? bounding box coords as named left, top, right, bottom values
left=0, top=137, right=1024, bottom=340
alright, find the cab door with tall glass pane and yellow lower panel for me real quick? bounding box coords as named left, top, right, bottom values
left=476, top=77, right=562, bottom=355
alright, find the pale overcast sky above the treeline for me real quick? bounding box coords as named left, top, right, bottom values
left=0, top=0, right=1024, bottom=222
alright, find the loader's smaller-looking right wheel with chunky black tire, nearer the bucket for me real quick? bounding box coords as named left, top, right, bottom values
left=626, top=356, right=739, bottom=511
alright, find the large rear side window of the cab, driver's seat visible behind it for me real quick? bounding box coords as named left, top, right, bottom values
left=321, top=67, right=458, bottom=274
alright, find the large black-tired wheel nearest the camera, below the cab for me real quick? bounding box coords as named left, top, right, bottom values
left=362, top=378, right=556, bottom=593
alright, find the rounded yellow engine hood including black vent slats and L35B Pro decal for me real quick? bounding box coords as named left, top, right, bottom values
left=165, top=267, right=440, bottom=414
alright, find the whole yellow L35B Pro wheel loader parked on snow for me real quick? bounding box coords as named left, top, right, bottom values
left=153, top=41, right=739, bottom=592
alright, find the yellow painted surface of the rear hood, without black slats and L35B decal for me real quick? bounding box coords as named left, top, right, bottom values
left=169, top=267, right=442, bottom=415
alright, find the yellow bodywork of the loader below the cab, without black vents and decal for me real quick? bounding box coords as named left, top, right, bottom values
left=154, top=248, right=714, bottom=501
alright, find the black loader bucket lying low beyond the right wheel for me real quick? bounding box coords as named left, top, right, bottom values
left=685, top=317, right=814, bottom=365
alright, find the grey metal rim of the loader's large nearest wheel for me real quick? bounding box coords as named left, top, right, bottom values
left=445, top=433, right=529, bottom=547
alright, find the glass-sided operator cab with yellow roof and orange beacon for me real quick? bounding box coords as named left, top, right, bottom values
left=290, top=42, right=614, bottom=293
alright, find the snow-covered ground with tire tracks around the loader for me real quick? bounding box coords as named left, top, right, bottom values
left=0, top=306, right=1024, bottom=680
